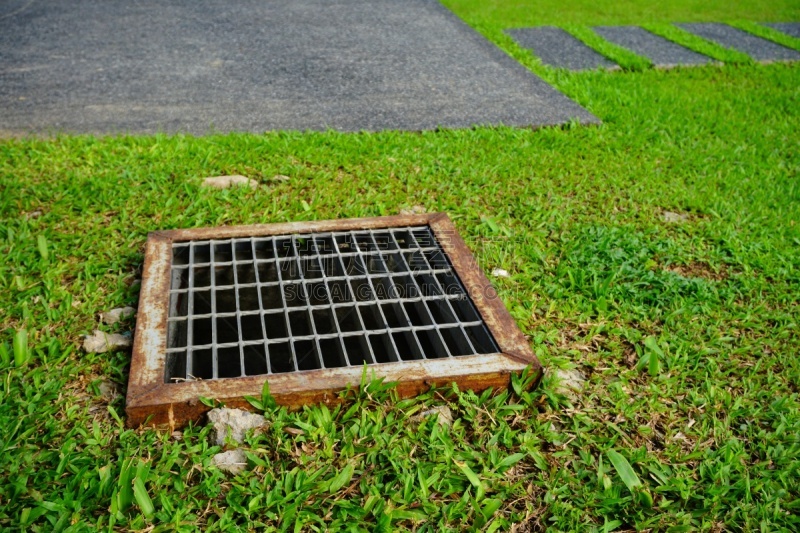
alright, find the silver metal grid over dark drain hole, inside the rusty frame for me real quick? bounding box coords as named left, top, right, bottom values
left=165, top=226, right=499, bottom=382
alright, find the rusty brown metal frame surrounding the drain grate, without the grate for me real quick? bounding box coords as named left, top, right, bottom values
left=126, top=213, right=542, bottom=428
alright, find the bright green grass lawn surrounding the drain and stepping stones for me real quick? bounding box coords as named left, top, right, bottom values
left=0, top=0, right=800, bottom=532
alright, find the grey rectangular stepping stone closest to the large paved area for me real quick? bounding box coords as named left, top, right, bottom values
left=506, top=26, right=619, bottom=70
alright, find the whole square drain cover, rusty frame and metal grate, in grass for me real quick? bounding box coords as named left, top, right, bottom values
left=126, top=213, right=541, bottom=427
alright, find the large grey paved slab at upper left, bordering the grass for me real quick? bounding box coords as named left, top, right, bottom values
left=0, top=0, right=597, bottom=135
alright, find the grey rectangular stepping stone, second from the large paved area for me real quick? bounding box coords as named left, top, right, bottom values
left=593, top=26, right=713, bottom=67
